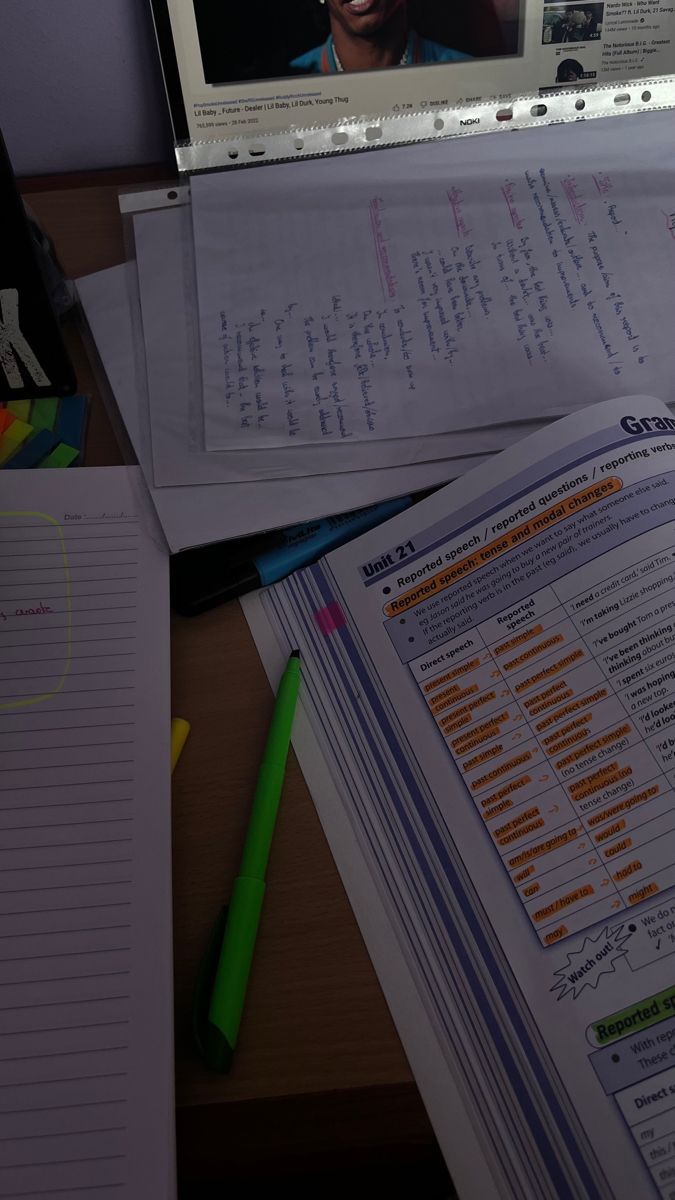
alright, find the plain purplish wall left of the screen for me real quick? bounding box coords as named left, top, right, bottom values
left=0, top=0, right=172, bottom=175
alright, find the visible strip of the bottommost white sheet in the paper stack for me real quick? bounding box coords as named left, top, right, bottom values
left=77, top=264, right=494, bottom=552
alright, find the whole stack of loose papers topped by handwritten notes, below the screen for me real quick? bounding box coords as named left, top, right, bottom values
left=74, top=114, right=675, bottom=550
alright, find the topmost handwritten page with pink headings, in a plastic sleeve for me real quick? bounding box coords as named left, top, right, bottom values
left=192, top=113, right=675, bottom=449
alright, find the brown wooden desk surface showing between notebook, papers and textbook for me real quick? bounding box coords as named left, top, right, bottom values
left=19, top=172, right=450, bottom=1200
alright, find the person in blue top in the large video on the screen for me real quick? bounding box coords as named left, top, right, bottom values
left=291, top=0, right=471, bottom=74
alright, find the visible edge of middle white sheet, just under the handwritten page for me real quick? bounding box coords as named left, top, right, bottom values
left=133, top=205, right=522, bottom=487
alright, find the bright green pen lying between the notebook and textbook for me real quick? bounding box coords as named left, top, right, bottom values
left=193, top=650, right=300, bottom=1072
